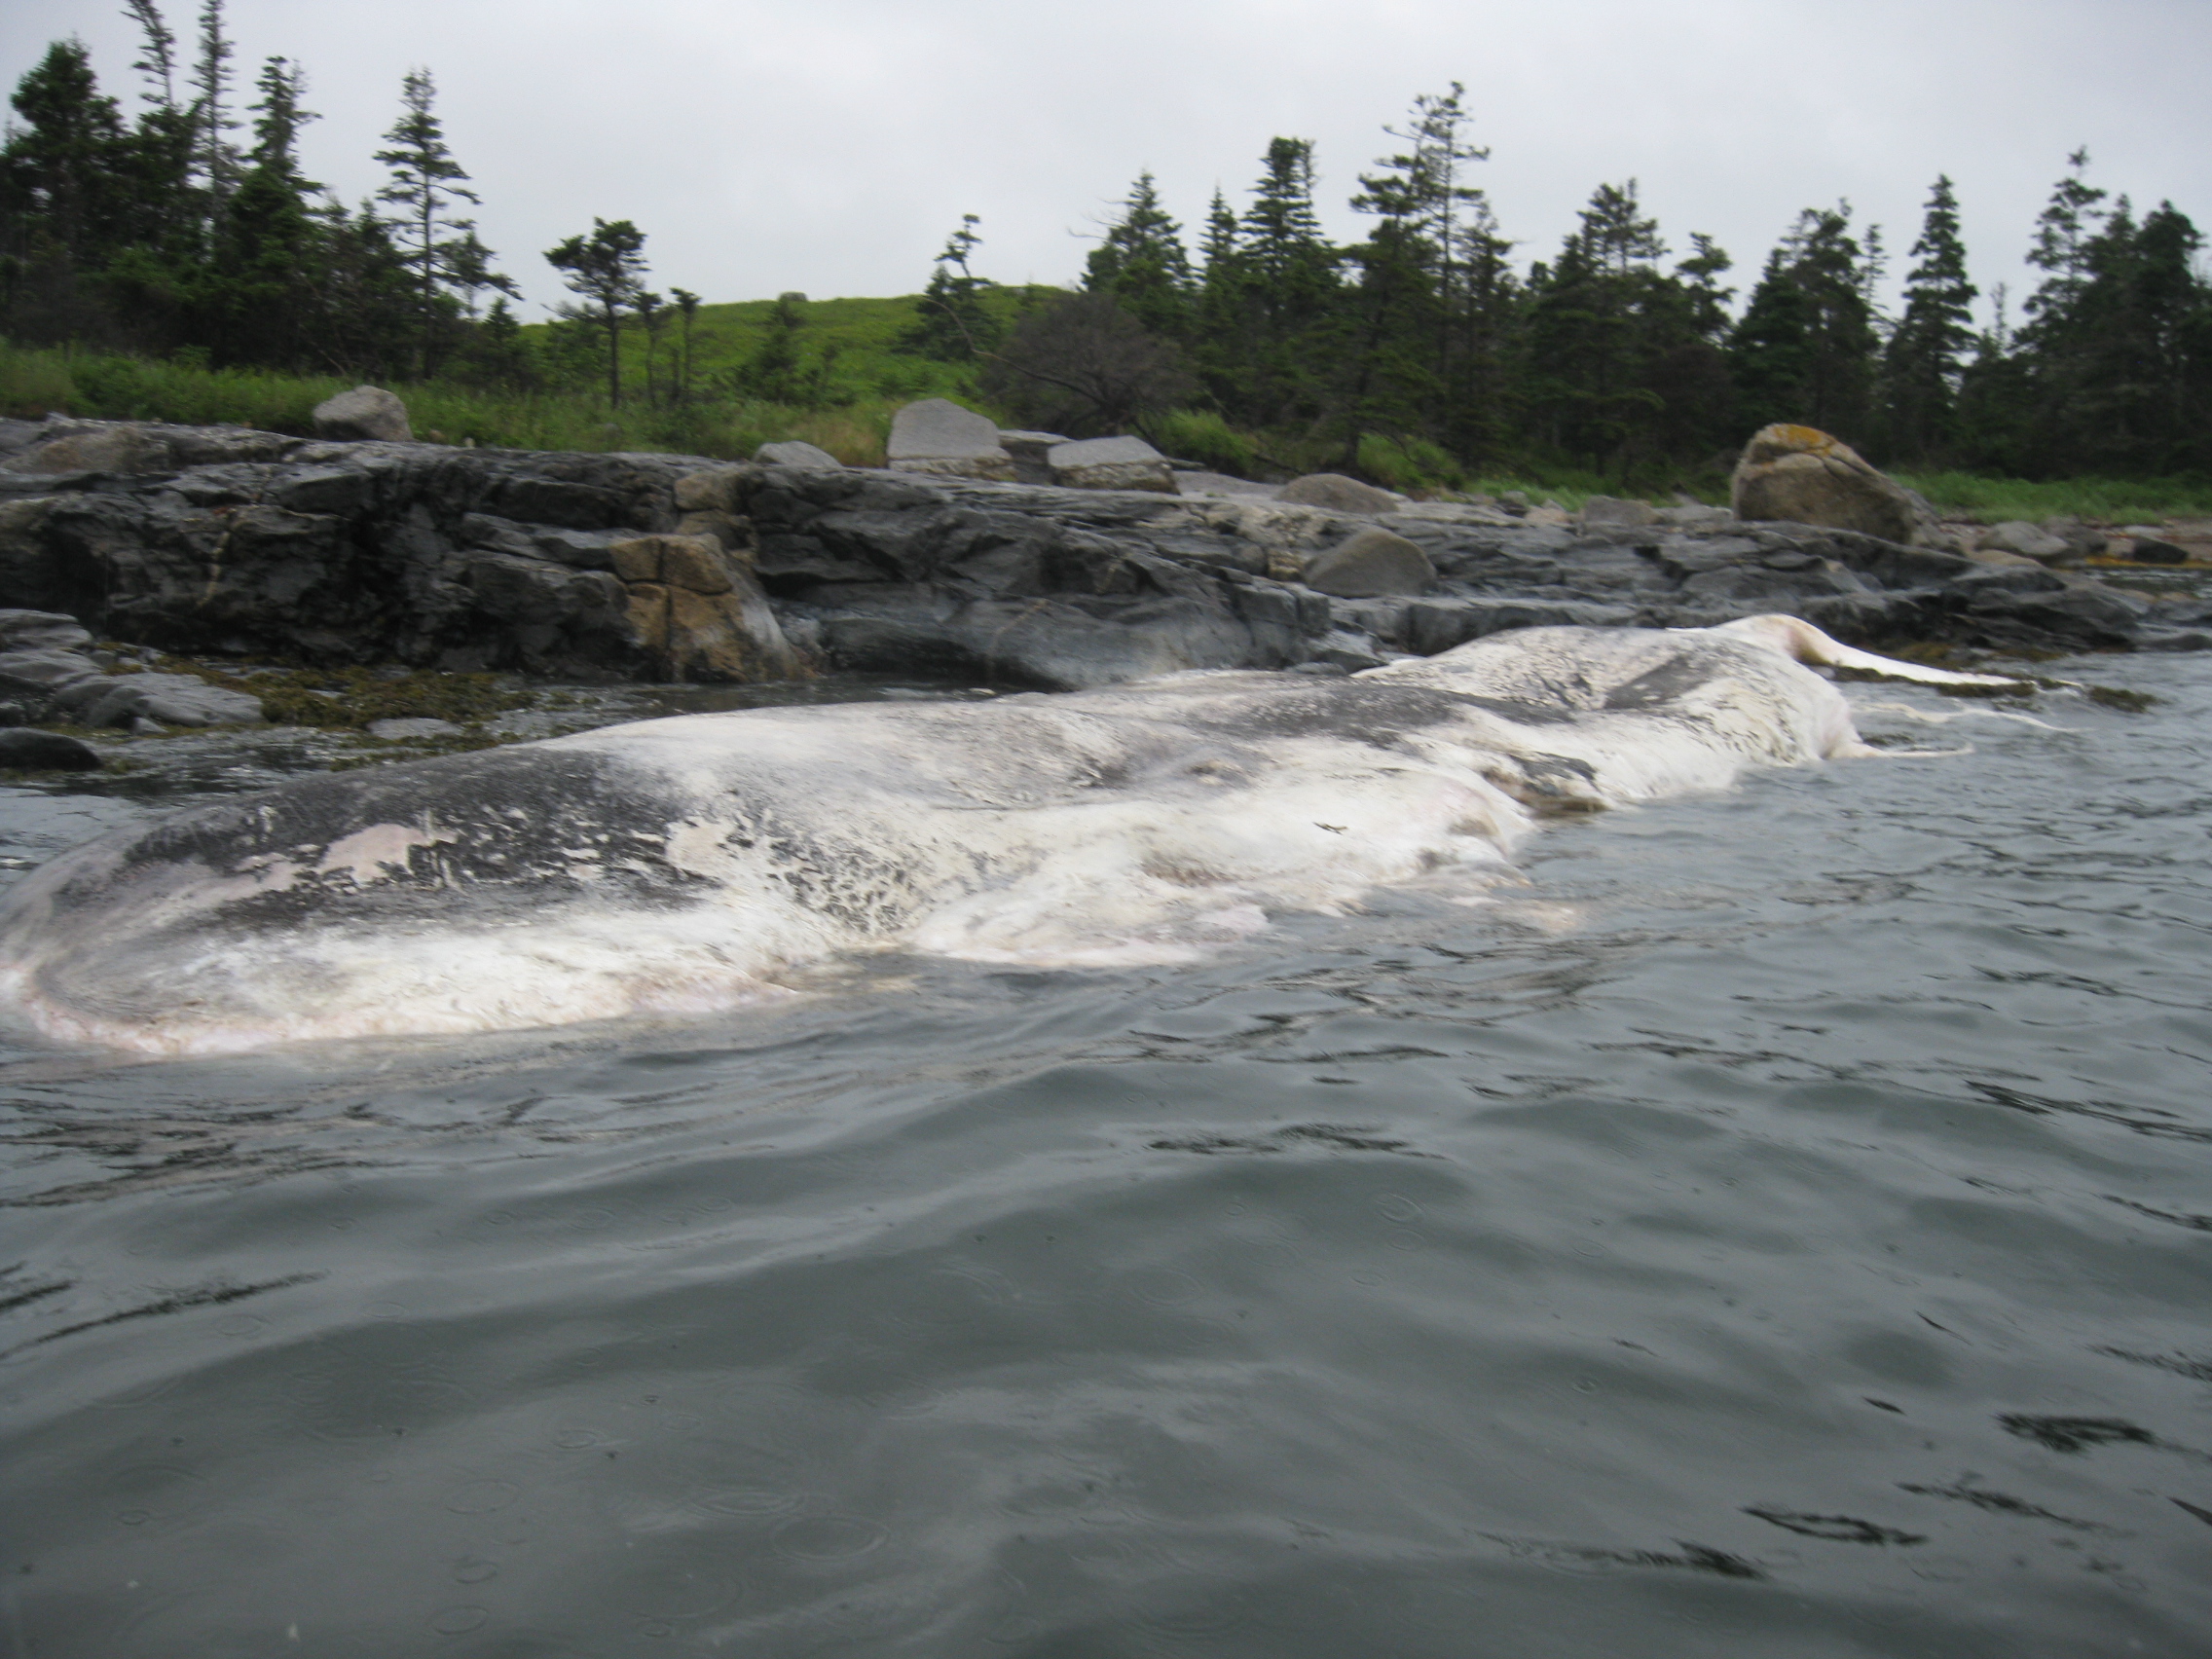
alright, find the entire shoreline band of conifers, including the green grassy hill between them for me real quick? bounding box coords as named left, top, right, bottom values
left=0, top=0, right=2212, bottom=482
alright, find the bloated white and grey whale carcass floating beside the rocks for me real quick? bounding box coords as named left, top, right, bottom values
left=0, top=617, right=2002, bottom=1052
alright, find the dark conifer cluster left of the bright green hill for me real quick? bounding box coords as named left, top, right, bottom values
left=0, top=0, right=699, bottom=403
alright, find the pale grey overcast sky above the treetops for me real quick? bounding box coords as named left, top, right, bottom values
left=0, top=0, right=2212, bottom=329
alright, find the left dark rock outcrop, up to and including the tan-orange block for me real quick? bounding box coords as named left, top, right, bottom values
left=0, top=423, right=796, bottom=680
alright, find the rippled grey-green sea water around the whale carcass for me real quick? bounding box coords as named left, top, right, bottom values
left=0, top=657, right=2212, bottom=1659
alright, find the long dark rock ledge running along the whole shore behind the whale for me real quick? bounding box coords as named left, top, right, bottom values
left=0, top=421, right=2205, bottom=690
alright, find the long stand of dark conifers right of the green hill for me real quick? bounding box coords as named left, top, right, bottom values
left=927, top=84, right=2212, bottom=478
